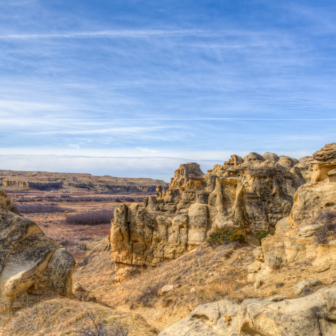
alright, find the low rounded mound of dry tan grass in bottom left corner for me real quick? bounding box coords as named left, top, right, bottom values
left=3, top=298, right=157, bottom=336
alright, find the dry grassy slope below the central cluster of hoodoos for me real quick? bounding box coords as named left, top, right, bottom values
left=74, top=240, right=255, bottom=329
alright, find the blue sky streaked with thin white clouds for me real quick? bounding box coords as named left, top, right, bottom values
left=0, top=0, right=336, bottom=181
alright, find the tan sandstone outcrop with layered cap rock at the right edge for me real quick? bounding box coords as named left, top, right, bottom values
left=249, top=144, right=336, bottom=281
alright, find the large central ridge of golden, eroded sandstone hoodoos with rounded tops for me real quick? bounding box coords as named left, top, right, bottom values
left=110, top=153, right=305, bottom=281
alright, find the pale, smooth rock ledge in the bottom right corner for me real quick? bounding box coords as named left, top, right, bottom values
left=159, top=287, right=336, bottom=336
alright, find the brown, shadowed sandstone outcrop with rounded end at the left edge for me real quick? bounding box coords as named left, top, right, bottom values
left=0, top=192, right=75, bottom=307
